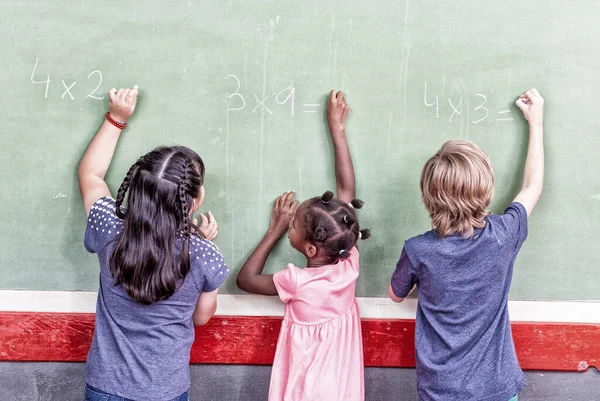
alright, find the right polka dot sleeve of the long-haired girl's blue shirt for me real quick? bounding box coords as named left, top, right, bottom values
left=190, top=235, right=229, bottom=292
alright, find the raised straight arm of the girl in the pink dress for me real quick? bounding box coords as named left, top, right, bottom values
left=327, top=91, right=356, bottom=203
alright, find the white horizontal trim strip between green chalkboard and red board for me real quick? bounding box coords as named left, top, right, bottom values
left=0, top=290, right=600, bottom=324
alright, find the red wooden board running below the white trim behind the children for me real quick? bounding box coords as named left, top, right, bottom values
left=0, top=312, right=600, bottom=371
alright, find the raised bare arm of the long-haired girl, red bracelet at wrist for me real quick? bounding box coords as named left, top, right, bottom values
left=77, top=85, right=138, bottom=214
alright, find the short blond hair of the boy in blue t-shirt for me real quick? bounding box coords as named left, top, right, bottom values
left=421, top=140, right=494, bottom=238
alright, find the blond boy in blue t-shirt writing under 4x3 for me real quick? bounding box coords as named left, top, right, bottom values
left=388, top=89, right=544, bottom=401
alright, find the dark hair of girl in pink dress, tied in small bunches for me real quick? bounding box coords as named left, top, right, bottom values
left=303, top=191, right=371, bottom=262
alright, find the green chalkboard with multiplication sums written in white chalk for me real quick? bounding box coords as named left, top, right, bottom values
left=0, top=0, right=600, bottom=300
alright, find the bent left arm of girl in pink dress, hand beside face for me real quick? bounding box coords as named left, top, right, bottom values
left=237, top=192, right=298, bottom=295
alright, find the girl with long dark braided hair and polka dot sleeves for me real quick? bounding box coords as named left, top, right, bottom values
left=79, top=86, right=229, bottom=401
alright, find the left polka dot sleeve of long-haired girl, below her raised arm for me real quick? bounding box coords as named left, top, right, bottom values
left=84, top=197, right=123, bottom=253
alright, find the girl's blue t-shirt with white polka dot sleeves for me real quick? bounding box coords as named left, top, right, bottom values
left=85, top=198, right=229, bottom=401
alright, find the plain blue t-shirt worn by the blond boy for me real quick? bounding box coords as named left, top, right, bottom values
left=391, top=202, right=527, bottom=401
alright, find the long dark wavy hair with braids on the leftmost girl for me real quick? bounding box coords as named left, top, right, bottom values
left=110, top=146, right=204, bottom=305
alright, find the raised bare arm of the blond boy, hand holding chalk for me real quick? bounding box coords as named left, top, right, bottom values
left=514, top=89, right=544, bottom=216
